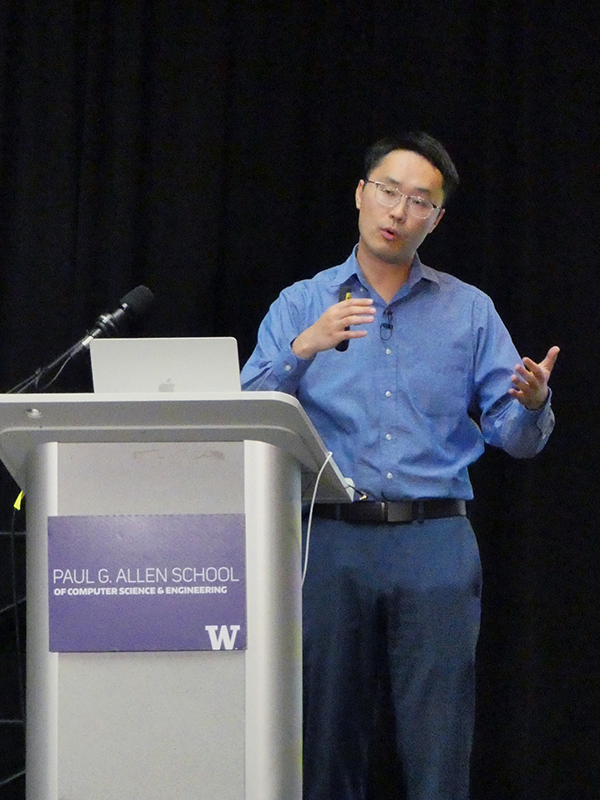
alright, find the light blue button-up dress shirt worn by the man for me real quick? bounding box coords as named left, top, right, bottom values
left=242, top=252, right=554, bottom=500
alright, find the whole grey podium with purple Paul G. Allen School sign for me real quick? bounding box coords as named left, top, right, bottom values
left=0, top=392, right=351, bottom=800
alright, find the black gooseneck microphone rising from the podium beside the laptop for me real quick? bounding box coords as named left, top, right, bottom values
left=7, top=286, right=154, bottom=394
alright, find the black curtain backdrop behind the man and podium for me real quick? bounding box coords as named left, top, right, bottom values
left=0, top=0, right=600, bottom=800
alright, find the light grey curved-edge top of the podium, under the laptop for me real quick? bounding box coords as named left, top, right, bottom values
left=0, top=392, right=352, bottom=502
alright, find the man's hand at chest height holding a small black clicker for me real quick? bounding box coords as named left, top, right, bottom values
left=292, top=297, right=375, bottom=358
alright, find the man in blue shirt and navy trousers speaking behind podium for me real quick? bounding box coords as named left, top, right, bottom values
left=242, top=133, right=559, bottom=800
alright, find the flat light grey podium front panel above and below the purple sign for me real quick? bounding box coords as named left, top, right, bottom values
left=27, top=442, right=246, bottom=800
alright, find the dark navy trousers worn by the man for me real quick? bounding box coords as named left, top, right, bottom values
left=303, top=517, right=481, bottom=800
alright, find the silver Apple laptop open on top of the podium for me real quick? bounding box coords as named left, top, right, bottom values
left=90, top=336, right=241, bottom=393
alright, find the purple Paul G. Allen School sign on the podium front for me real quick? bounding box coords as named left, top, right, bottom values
left=48, top=514, right=247, bottom=652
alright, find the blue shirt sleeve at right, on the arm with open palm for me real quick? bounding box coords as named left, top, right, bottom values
left=474, top=298, right=554, bottom=458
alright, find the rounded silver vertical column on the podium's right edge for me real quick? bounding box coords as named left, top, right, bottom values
left=245, top=442, right=302, bottom=800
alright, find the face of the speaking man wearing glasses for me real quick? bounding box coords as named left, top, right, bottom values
left=356, top=150, right=444, bottom=265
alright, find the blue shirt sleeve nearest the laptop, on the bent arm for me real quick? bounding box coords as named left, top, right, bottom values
left=241, top=290, right=314, bottom=395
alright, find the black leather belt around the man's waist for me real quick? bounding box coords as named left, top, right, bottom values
left=313, top=497, right=467, bottom=523
